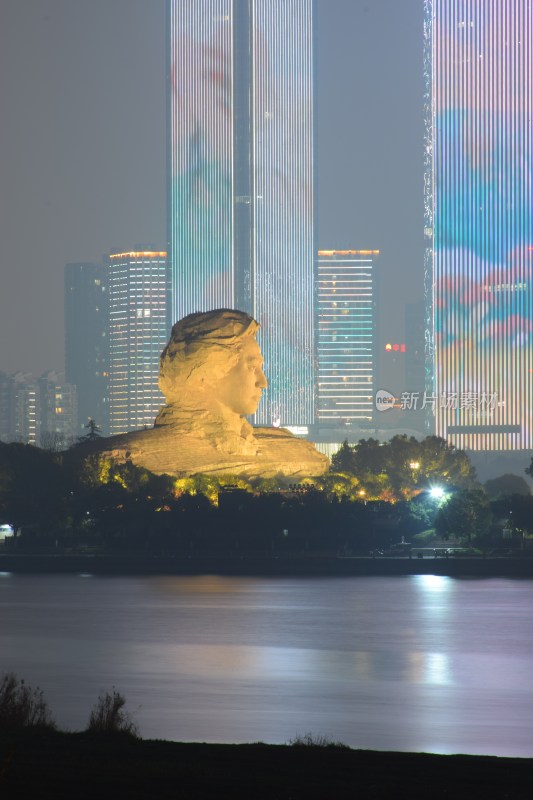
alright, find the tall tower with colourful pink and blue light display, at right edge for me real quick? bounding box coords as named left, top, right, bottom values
left=425, top=0, right=533, bottom=450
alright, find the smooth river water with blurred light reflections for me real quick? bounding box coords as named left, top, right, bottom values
left=0, top=573, right=533, bottom=757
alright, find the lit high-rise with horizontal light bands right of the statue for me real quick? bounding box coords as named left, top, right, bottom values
left=317, top=250, right=379, bottom=429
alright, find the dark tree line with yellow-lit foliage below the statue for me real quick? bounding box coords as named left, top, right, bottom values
left=0, top=438, right=533, bottom=555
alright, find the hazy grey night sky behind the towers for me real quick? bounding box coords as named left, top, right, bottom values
left=0, top=0, right=423, bottom=375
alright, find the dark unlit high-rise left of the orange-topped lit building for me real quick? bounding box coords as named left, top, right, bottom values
left=65, top=263, right=108, bottom=436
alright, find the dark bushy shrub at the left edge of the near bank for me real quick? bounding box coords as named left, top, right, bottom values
left=0, top=672, right=55, bottom=729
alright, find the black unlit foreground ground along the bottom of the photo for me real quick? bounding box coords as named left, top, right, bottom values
left=0, top=731, right=533, bottom=800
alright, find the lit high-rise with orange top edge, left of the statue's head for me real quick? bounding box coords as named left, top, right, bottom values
left=107, top=250, right=168, bottom=434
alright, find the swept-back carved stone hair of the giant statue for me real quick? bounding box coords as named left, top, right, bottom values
left=159, top=308, right=259, bottom=404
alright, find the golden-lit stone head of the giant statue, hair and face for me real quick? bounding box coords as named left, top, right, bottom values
left=159, top=309, right=267, bottom=416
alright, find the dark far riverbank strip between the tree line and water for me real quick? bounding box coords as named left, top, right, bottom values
left=0, top=553, right=533, bottom=578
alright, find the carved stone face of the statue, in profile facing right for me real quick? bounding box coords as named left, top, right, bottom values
left=215, top=336, right=268, bottom=416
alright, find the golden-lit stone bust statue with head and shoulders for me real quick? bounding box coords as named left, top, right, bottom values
left=99, top=309, right=329, bottom=479
